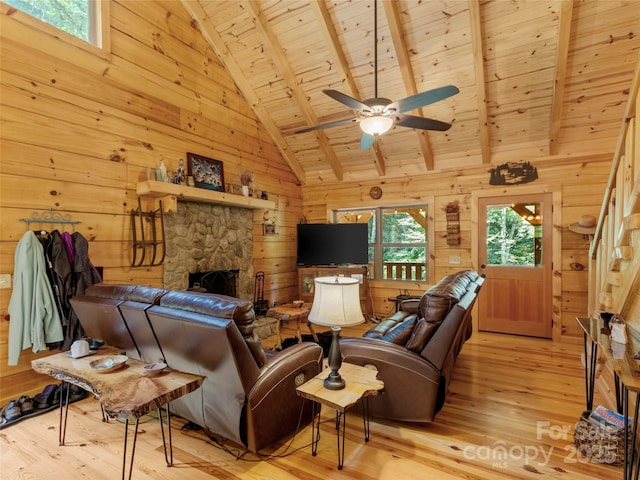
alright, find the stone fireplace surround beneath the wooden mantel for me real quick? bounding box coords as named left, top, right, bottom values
left=164, top=202, right=254, bottom=302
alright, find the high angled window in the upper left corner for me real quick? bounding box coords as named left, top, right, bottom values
left=3, top=0, right=104, bottom=47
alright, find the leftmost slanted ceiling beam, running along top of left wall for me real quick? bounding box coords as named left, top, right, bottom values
left=176, top=0, right=306, bottom=184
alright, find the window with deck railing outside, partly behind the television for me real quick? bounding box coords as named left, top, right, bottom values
left=335, top=205, right=428, bottom=281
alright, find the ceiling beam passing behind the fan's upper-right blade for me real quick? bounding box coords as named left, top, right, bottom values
left=382, top=1, right=434, bottom=170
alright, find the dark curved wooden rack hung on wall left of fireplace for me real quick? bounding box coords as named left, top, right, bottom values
left=131, top=197, right=166, bottom=267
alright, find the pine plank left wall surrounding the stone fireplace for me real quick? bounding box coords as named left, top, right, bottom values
left=0, top=1, right=301, bottom=403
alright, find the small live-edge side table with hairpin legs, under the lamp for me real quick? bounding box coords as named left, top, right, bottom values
left=296, top=363, right=384, bottom=470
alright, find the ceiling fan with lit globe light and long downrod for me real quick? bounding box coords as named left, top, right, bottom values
left=294, top=0, right=460, bottom=150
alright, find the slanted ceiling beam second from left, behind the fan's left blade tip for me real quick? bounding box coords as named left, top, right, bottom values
left=246, top=0, right=343, bottom=180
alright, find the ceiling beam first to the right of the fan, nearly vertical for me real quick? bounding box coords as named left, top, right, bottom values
left=469, top=0, right=491, bottom=164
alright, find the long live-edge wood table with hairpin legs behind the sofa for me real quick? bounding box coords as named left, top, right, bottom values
left=31, top=346, right=204, bottom=479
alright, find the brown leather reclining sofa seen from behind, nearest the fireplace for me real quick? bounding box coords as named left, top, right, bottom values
left=71, top=284, right=322, bottom=452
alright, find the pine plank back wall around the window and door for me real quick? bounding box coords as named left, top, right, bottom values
left=303, top=160, right=610, bottom=342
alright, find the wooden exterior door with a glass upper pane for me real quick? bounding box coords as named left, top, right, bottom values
left=478, top=193, right=553, bottom=338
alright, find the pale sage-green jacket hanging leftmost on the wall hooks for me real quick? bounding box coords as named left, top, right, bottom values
left=8, top=231, right=64, bottom=365
